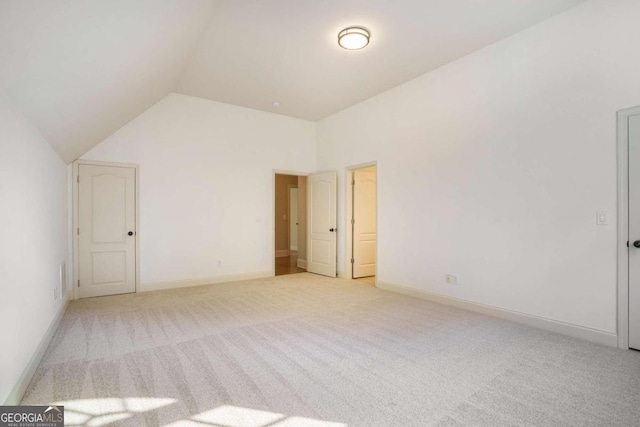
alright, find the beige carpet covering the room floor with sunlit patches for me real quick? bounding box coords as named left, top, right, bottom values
left=22, top=273, right=640, bottom=427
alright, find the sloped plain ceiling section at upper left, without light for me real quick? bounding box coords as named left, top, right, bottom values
left=0, top=0, right=216, bottom=162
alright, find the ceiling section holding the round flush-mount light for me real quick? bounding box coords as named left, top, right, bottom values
left=177, top=0, right=584, bottom=120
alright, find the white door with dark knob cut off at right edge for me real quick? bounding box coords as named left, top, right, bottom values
left=629, top=115, right=640, bottom=350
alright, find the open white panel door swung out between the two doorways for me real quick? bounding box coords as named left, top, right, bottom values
left=307, top=172, right=337, bottom=277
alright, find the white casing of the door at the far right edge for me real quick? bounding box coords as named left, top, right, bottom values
left=617, top=106, right=640, bottom=350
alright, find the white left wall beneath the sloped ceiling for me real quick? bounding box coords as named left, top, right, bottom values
left=0, top=94, right=67, bottom=403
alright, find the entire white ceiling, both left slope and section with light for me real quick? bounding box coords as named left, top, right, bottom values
left=0, top=0, right=585, bottom=161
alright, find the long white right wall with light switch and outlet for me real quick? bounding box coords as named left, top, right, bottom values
left=317, top=0, right=640, bottom=333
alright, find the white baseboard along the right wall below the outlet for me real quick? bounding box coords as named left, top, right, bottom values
left=376, top=281, right=618, bottom=347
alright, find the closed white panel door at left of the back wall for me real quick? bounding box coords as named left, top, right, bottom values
left=77, top=165, right=136, bottom=298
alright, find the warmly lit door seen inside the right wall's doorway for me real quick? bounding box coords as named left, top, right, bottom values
left=352, top=169, right=376, bottom=279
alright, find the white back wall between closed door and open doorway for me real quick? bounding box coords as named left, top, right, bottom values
left=82, top=94, right=315, bottom=285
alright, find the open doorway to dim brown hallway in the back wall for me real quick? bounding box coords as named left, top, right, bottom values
left=274, top=173, right=307, bottom=276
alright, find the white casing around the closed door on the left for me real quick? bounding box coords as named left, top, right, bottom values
left=71, top=159, right=140, bottom=299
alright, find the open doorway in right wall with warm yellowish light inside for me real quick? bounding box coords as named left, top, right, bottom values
left=347, top=164, right=377, bottom=285
